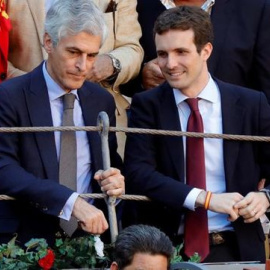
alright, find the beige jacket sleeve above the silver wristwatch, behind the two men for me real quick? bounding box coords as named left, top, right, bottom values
left=101, top=0, right=143, bottom=88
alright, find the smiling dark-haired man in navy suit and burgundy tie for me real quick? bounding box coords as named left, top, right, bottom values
left=123, top=6, right=270, bottom=262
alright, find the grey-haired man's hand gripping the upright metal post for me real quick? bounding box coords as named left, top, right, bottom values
left=94, top=168, right=125, bottom=197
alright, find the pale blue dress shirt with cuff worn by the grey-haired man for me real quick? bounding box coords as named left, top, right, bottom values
left=43, top=62, right=91, bottom=220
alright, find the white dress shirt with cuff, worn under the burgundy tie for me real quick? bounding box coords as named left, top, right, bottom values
left=173, top=75, right=232, bottom=232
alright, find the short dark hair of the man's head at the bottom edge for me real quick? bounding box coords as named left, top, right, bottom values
left=114, top=224, right=173, bottom=270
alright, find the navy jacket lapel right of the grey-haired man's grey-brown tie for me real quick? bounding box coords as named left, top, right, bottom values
left=78, top=85, right=102, bottom=172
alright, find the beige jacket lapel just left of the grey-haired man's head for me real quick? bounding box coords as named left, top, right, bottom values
left=27, top=0, right=47, bottom=59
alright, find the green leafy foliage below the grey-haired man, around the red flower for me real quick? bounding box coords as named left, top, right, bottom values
left=0, top=235, right=109, bottom=270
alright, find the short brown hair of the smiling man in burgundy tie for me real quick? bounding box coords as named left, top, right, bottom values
left=154, top=6, right=214, bottom=53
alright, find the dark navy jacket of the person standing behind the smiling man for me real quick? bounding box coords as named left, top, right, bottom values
left=121, top=0, right=270, bottom=101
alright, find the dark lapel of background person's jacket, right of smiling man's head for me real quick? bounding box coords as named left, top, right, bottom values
left=208, top=0, right=235, bottom=73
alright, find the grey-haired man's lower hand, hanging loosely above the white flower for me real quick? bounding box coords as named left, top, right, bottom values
left=72, top=197, right=109, bottom=234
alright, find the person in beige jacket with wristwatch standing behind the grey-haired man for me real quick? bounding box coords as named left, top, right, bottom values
left=6, top=0, right=143, bottom=155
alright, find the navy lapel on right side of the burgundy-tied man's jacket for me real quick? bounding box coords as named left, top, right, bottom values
left=217, top=81, right=244, bottom=188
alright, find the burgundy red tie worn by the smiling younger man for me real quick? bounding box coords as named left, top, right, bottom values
left=184, top=98, right=209, bottom=261
